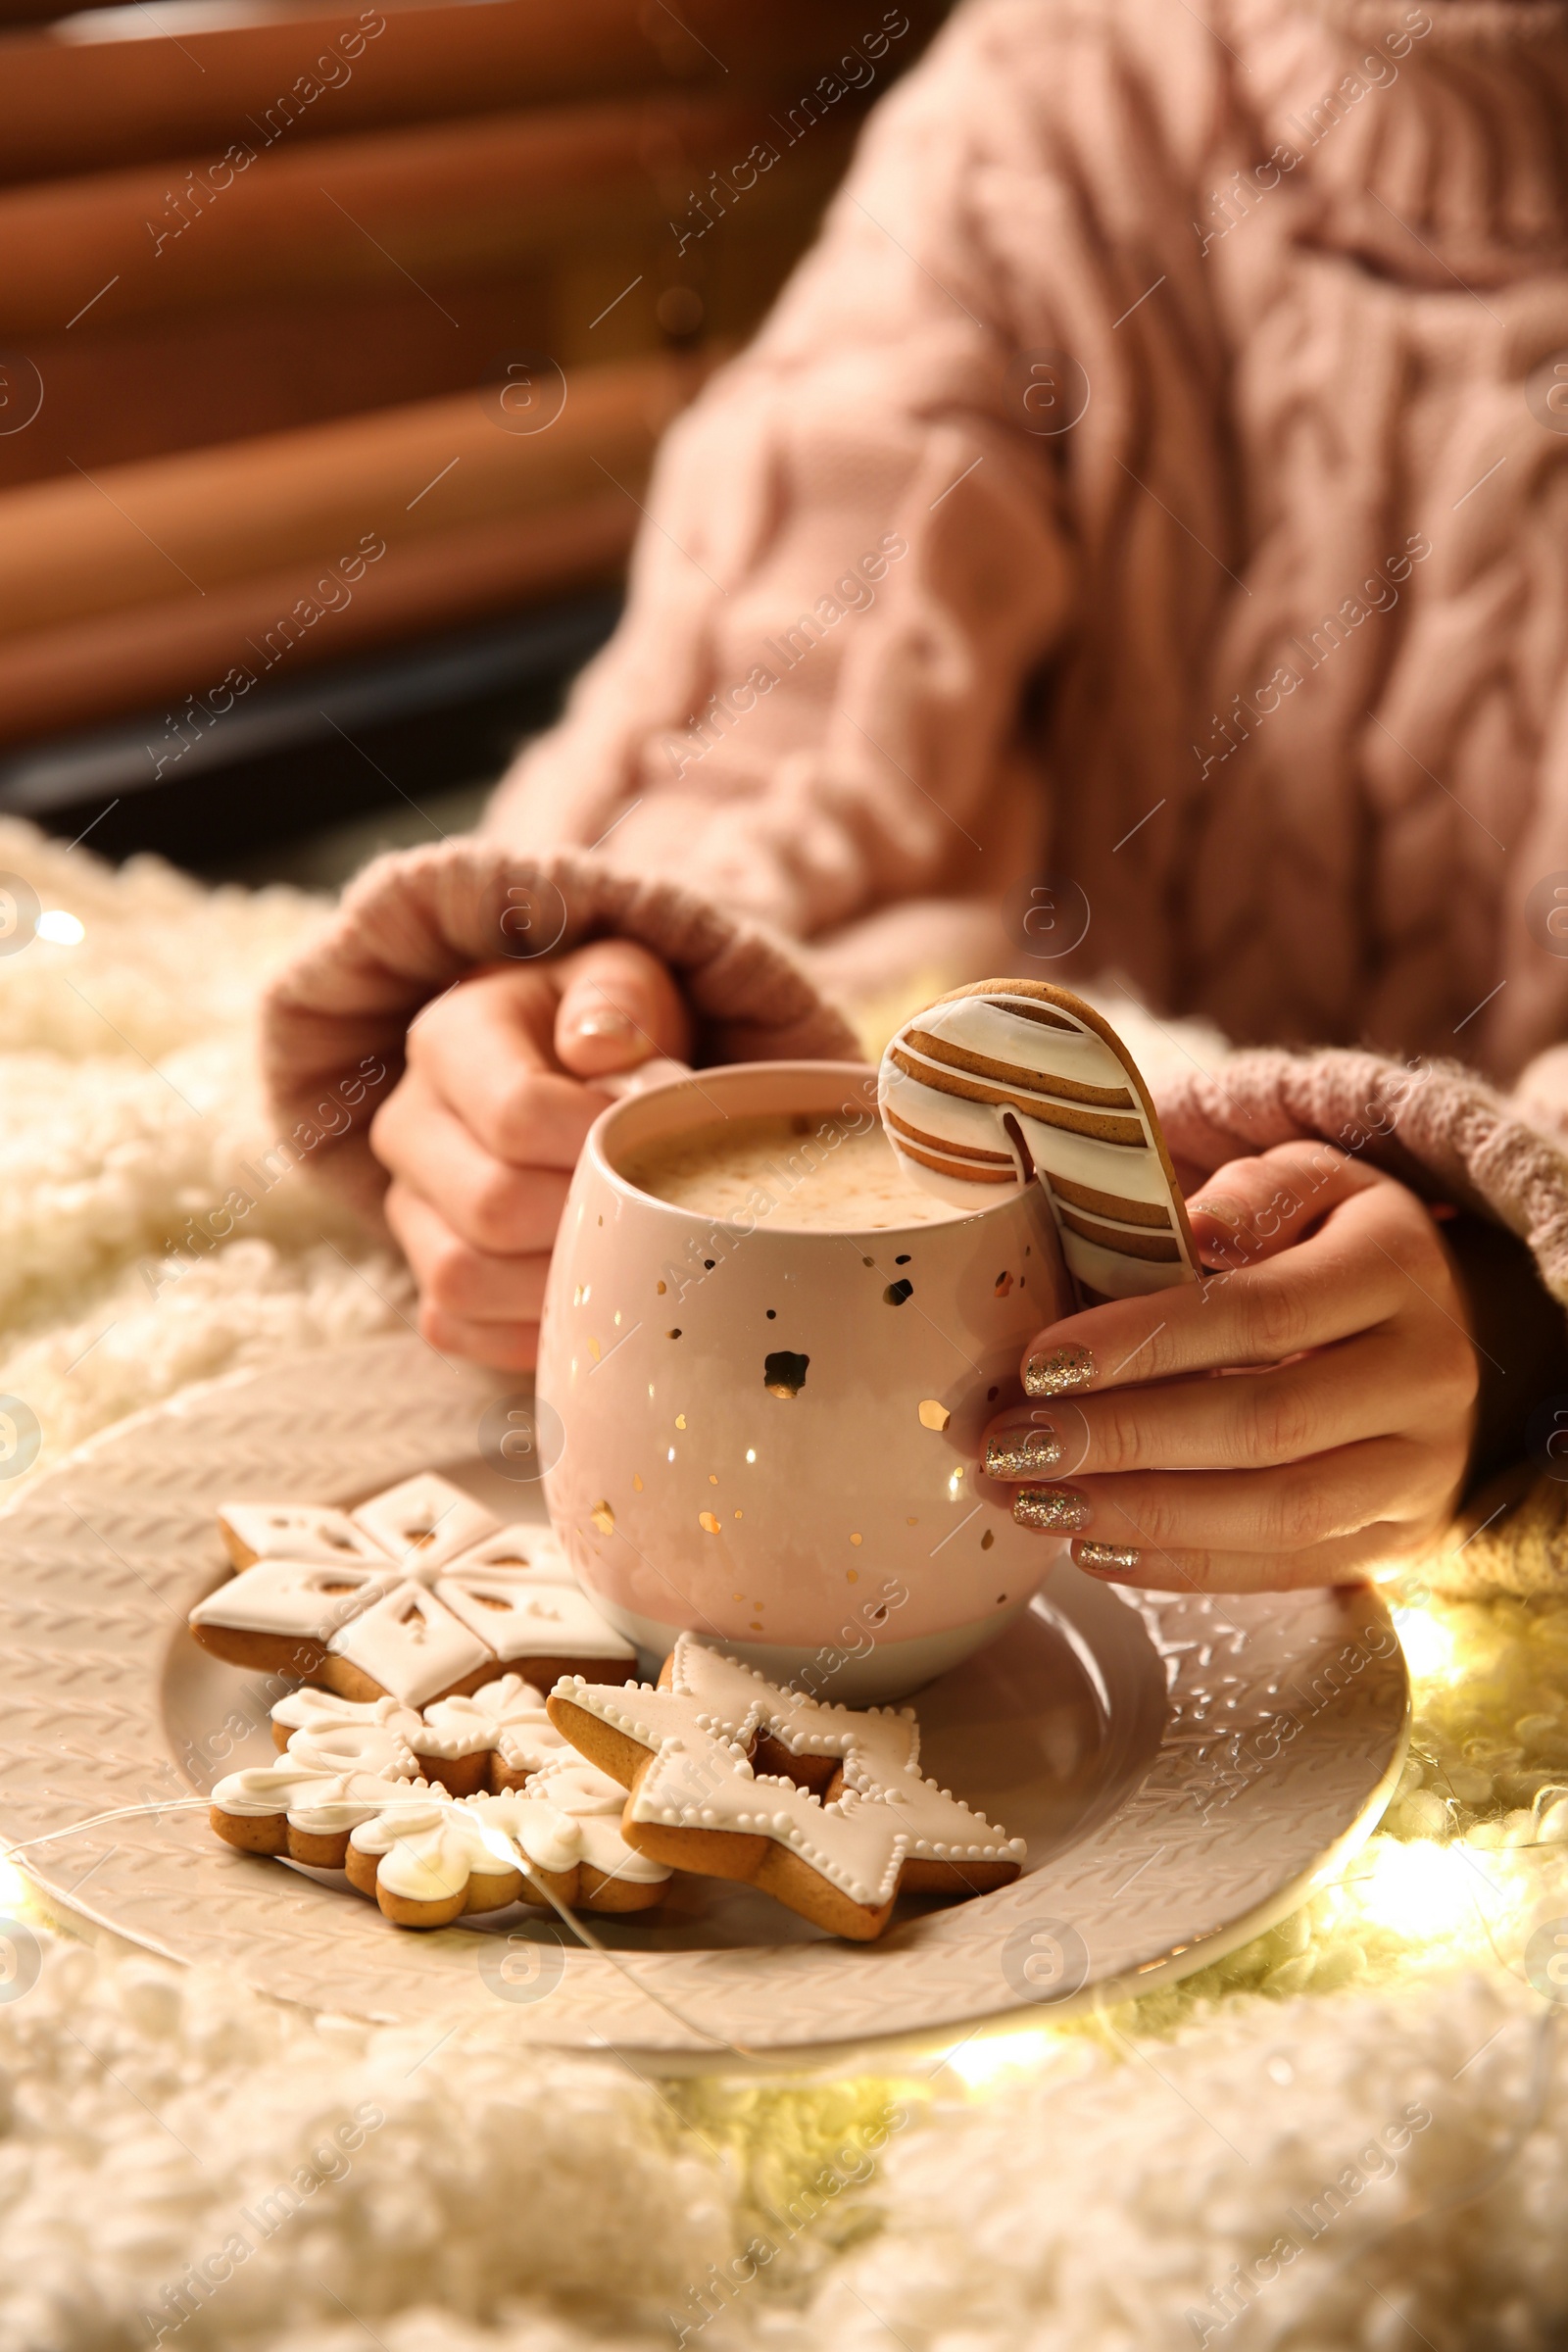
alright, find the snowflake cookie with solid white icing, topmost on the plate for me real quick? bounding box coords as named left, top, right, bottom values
left=190, top=1472, right=637, bottom=1707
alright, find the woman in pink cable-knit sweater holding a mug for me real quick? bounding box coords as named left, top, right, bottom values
left=270, top=0, right=1568, bottom=1588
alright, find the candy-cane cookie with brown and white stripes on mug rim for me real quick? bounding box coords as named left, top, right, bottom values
left=877, top=981, right=1199, bottom=1305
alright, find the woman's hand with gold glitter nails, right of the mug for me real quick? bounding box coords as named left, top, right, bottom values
left=985, top=1143, right=1479, bottom=1592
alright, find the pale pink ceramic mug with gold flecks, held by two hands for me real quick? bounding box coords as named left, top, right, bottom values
left=538, top=1060, right=1069, bottom=1703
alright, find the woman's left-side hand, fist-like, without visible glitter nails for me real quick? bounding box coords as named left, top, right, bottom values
left=369, top=939, right=691, bottom=1371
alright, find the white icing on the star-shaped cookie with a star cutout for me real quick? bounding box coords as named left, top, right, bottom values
left=553, top=1635, right=1027, bottom=1907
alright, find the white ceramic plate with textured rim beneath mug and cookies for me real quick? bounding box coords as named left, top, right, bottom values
left=0, top=1336, right=1408, bottom=2065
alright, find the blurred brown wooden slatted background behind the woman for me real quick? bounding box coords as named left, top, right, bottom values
left=0, top=0, right=943, bottom=884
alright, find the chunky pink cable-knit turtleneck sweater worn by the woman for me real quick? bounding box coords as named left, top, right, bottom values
left=268, top=0, right=1568, bottom=1599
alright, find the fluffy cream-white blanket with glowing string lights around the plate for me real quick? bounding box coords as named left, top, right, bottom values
left=0, top=825, right=1568, bottom=2352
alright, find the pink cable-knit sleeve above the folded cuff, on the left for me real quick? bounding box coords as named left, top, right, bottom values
left=487, top=12, right=1072, bottom=939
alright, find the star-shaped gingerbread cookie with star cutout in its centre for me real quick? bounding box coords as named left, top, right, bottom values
left=550, top=1635, right=1025, bottom=1942
